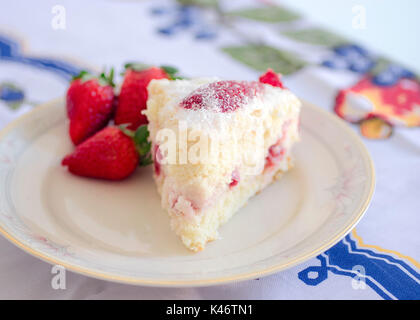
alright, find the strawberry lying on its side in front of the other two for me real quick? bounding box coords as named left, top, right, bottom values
left=61, top=126, right=152, bottom=180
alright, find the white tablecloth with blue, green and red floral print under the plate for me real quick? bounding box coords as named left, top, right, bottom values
left=0, top=0, right=420, bottom=299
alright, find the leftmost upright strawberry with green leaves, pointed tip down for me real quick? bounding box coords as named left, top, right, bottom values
left=66, top=70, right=114, bottom=145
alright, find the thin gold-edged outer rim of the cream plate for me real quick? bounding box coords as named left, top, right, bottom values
left=0, top=97, right=376, bottom=287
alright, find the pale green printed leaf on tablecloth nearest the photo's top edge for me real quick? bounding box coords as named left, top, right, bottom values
left=227, top=6, right=300, bottom=23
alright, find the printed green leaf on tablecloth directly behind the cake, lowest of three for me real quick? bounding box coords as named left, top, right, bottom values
left=222, top=45, right=306, bottom=75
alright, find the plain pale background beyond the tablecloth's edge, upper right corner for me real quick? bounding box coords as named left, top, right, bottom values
left=277, top=0, right=420, bottom=71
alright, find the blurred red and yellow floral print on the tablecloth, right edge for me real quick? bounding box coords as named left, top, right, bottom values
left=334, top=76, right=420, bottom=139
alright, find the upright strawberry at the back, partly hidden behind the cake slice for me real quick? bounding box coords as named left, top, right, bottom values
left=114, top=64, right=169, bottom=130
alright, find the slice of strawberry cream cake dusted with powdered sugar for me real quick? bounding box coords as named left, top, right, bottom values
left=143, top=70, right=301, bottom=251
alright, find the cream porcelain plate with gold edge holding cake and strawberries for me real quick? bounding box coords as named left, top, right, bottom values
left=0, top=100, right=374, bottom=286
